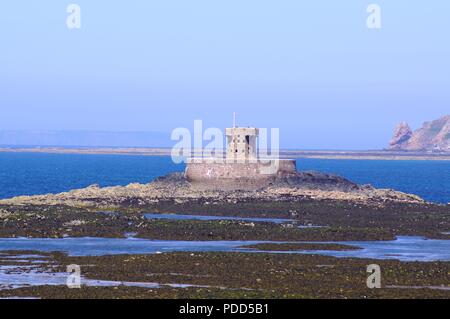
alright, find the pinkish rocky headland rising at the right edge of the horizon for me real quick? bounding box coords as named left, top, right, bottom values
left=389, top=115, right=450, bottom=152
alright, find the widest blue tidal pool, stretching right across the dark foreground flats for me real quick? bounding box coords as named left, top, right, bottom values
left=0, top=236, right=450, bottom=261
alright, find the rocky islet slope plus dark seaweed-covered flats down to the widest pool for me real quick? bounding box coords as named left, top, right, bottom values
left=0, top=172, right=450, bottom=241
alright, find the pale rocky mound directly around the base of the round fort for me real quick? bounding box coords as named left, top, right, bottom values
left=0, top=172, right=423, bottom=208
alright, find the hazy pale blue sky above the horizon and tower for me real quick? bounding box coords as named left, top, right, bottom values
left=0, top=0, right=450, bottom=149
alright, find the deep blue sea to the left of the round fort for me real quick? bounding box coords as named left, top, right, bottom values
left=0, top=153, right=184, bottom=198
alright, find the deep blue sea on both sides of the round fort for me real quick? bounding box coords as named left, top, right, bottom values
left=0, top=153, right=450, bottom=203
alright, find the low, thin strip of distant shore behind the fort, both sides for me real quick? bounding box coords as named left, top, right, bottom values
left=0, top=146, right=450, bottom=161
